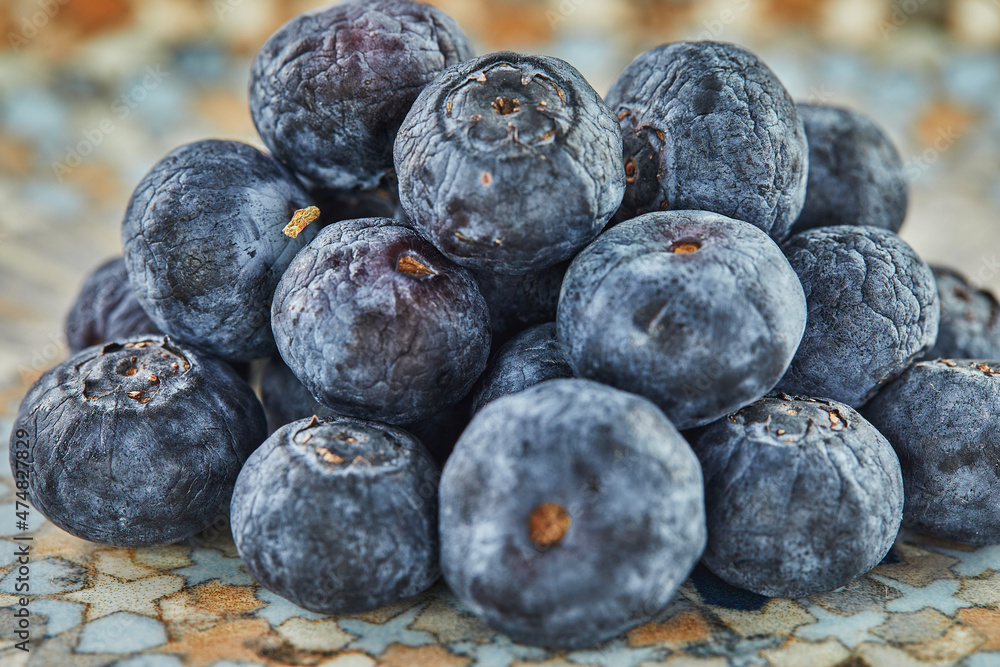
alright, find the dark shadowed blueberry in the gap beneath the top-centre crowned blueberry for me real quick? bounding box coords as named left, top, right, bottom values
left=471, top=262, right=569, bottom=341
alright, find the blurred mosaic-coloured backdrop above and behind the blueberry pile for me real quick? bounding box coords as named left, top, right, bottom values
left=0, top=0, right=1000, bottom=414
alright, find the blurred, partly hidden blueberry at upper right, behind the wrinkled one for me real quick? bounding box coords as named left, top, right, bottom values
left=792, top=104, right=909, bottom=234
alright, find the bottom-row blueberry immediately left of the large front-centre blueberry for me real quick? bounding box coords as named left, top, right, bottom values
left=232, top=418, right=440, bottom=614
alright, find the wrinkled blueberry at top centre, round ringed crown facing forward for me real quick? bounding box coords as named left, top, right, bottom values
left=395, top=52, right=625, bottom=274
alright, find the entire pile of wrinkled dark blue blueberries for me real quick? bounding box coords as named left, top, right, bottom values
left=11, top=0, right=1000, bottom=647
